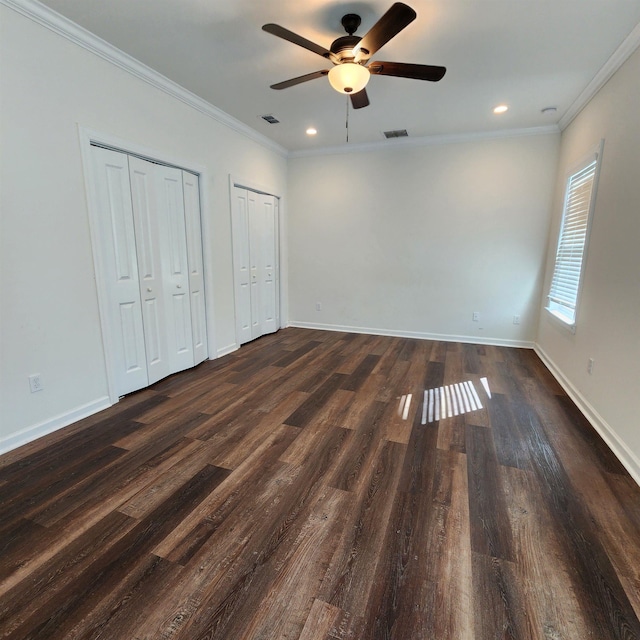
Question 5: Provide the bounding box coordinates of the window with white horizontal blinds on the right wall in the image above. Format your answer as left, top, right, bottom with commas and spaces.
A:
547, 143, 602, 330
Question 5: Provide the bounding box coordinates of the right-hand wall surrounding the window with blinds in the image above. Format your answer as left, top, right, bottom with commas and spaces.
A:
538, 50, 640, 482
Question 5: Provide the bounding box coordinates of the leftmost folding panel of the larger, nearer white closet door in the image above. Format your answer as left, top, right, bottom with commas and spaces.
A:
91, 147, 148, 395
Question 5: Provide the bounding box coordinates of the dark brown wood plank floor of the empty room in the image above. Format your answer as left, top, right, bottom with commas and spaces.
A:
0, 329, 640, 640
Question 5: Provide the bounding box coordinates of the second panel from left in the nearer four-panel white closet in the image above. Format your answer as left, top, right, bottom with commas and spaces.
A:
129, 157, 171, 384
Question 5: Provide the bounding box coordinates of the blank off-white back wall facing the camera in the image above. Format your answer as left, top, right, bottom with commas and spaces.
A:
288, 133, 559, 346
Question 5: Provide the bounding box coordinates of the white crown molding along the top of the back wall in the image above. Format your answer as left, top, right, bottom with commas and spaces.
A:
288, 124, 560, 158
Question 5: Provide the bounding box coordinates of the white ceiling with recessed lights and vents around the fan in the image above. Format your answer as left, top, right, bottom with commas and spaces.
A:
33, 0, 640, 151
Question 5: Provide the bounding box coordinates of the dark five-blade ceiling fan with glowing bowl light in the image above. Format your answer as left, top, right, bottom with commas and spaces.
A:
262, 2, 446, 109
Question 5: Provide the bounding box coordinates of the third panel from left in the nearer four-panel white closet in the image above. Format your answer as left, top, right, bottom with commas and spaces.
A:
155, 165, 194, 373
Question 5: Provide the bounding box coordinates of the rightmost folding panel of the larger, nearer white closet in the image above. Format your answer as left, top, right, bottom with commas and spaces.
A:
182, 171, 208, 364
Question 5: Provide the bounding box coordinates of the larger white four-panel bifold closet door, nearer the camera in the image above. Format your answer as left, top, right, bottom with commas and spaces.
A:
92, 147, 207, 395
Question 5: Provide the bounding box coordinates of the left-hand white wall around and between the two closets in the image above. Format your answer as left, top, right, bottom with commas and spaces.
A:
0, 5, 286, 450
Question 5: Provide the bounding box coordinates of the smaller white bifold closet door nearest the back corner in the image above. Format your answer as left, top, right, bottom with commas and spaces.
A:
231, 186, 279, 344
